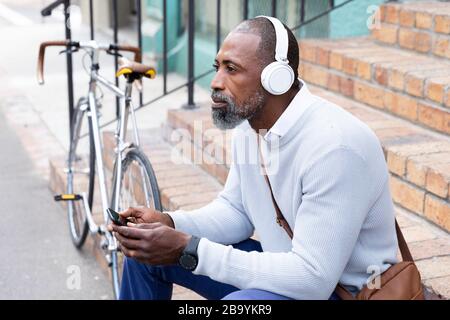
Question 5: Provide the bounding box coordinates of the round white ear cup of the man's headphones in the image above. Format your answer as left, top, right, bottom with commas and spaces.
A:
261, 61, 294, 96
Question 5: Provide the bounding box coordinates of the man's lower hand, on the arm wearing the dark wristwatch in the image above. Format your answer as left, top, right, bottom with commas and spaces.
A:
109, 223, 191, 265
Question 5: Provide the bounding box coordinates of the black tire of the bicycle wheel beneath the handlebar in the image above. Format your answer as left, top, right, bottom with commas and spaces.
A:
67, 98, 95, 249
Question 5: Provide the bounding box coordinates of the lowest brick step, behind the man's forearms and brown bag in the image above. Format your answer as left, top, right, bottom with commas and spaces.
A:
50, 127, 450, 299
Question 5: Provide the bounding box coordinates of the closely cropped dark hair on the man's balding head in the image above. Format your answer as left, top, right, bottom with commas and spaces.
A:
232, 17, 299, 87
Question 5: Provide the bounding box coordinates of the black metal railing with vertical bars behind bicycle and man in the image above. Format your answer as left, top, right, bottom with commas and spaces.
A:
41, 0, 374, 132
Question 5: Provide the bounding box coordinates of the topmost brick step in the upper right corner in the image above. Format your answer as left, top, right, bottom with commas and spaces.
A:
372, 1, 450, 59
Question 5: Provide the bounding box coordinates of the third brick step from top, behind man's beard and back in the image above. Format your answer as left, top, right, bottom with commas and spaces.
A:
164, 86, 450, 231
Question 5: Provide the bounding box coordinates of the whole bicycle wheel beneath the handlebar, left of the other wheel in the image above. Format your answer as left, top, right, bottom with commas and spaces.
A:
67, 99, 95, 248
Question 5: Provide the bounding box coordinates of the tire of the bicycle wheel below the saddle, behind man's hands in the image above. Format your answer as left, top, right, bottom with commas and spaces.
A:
111, 148, 162, 299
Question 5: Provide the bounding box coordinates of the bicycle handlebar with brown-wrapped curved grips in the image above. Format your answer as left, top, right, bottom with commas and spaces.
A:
37, 40, 142, 85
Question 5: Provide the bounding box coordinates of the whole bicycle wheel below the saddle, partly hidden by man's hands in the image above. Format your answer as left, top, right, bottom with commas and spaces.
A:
111, 148, 162, 298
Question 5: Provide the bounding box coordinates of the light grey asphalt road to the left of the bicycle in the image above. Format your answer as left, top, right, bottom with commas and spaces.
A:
0, 106, 112, 299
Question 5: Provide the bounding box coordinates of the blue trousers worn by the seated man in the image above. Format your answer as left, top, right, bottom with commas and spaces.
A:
119, 239, 339, 300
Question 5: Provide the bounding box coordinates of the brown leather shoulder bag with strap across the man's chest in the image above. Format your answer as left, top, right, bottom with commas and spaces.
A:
258, 139, 425, 300
